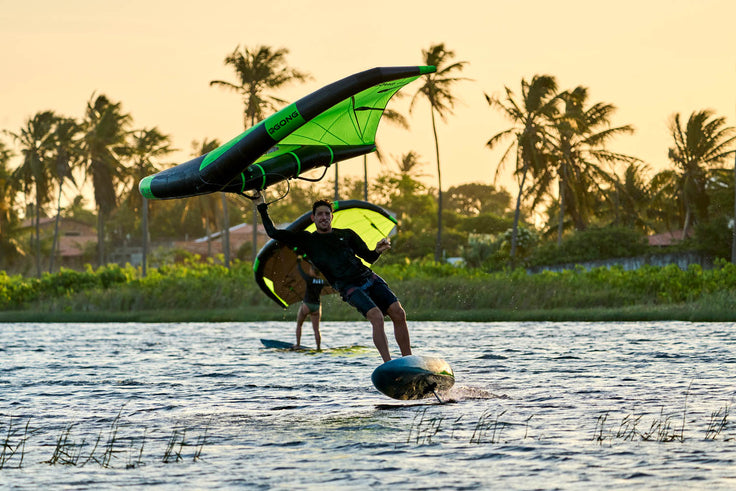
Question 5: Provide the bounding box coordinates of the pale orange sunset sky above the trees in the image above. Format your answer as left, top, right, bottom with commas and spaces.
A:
0, 0, 736, 198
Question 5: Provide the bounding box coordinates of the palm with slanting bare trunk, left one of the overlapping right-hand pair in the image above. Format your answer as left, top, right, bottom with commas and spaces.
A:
486, 75, 559, 264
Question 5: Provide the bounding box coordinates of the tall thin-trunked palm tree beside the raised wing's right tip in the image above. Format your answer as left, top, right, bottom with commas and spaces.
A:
409, 43, 468, 262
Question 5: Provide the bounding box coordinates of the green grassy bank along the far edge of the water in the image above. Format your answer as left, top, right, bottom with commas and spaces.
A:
0, 263, 736, 322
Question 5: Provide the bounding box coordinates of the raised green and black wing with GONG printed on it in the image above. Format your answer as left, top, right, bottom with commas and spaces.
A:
138, 66, 435, 199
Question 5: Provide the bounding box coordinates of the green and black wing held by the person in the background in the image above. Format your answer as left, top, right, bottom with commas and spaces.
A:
253, 200, 396, 308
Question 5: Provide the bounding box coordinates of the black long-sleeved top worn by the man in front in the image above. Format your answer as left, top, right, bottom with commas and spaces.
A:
258, 203, 381, 293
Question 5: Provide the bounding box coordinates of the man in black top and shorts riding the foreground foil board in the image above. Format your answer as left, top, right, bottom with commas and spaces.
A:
255, 194, 411, 362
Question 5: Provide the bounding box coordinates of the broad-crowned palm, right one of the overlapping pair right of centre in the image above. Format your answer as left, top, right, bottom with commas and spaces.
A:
548, 87, 637, 245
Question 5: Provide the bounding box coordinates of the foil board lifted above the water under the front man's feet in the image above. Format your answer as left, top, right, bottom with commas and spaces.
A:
371, 355, 455, 401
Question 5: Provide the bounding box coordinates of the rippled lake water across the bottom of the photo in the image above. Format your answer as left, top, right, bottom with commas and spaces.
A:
0, 322, 736, 490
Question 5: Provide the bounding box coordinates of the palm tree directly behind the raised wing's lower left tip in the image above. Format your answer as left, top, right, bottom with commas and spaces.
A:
121, 127, 174, 276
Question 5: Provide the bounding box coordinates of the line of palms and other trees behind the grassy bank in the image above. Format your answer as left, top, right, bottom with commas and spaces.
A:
0, 44, 736, 276
